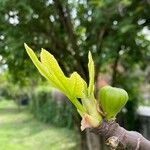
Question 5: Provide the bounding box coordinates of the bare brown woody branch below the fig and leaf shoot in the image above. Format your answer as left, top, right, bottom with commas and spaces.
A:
91, 121, 150, 150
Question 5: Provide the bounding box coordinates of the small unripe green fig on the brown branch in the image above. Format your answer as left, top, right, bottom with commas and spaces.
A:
98, 85, 128, 121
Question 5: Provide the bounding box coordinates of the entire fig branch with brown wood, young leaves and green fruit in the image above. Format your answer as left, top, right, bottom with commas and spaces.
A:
25, 44, 150, 150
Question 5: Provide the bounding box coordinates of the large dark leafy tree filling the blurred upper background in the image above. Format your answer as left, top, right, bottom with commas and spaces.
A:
0, 0, 150, 149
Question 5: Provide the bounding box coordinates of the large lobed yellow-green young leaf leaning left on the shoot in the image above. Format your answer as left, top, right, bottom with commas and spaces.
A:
24, 44, 87, 112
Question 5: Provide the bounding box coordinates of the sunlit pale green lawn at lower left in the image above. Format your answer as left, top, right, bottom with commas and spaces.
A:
0, 101, 78, 150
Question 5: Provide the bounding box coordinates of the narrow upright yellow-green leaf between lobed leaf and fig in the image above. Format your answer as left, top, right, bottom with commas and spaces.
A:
88, 51, 95, 97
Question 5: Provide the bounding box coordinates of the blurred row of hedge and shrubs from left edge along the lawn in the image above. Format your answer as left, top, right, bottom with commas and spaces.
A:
0, 74, 75, 128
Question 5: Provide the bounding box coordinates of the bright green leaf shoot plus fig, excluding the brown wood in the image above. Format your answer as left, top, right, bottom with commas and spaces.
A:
24, 44, 127, 130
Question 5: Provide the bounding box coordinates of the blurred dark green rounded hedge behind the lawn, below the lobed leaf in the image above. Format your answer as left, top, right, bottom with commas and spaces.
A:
29, 86, 75, 128
